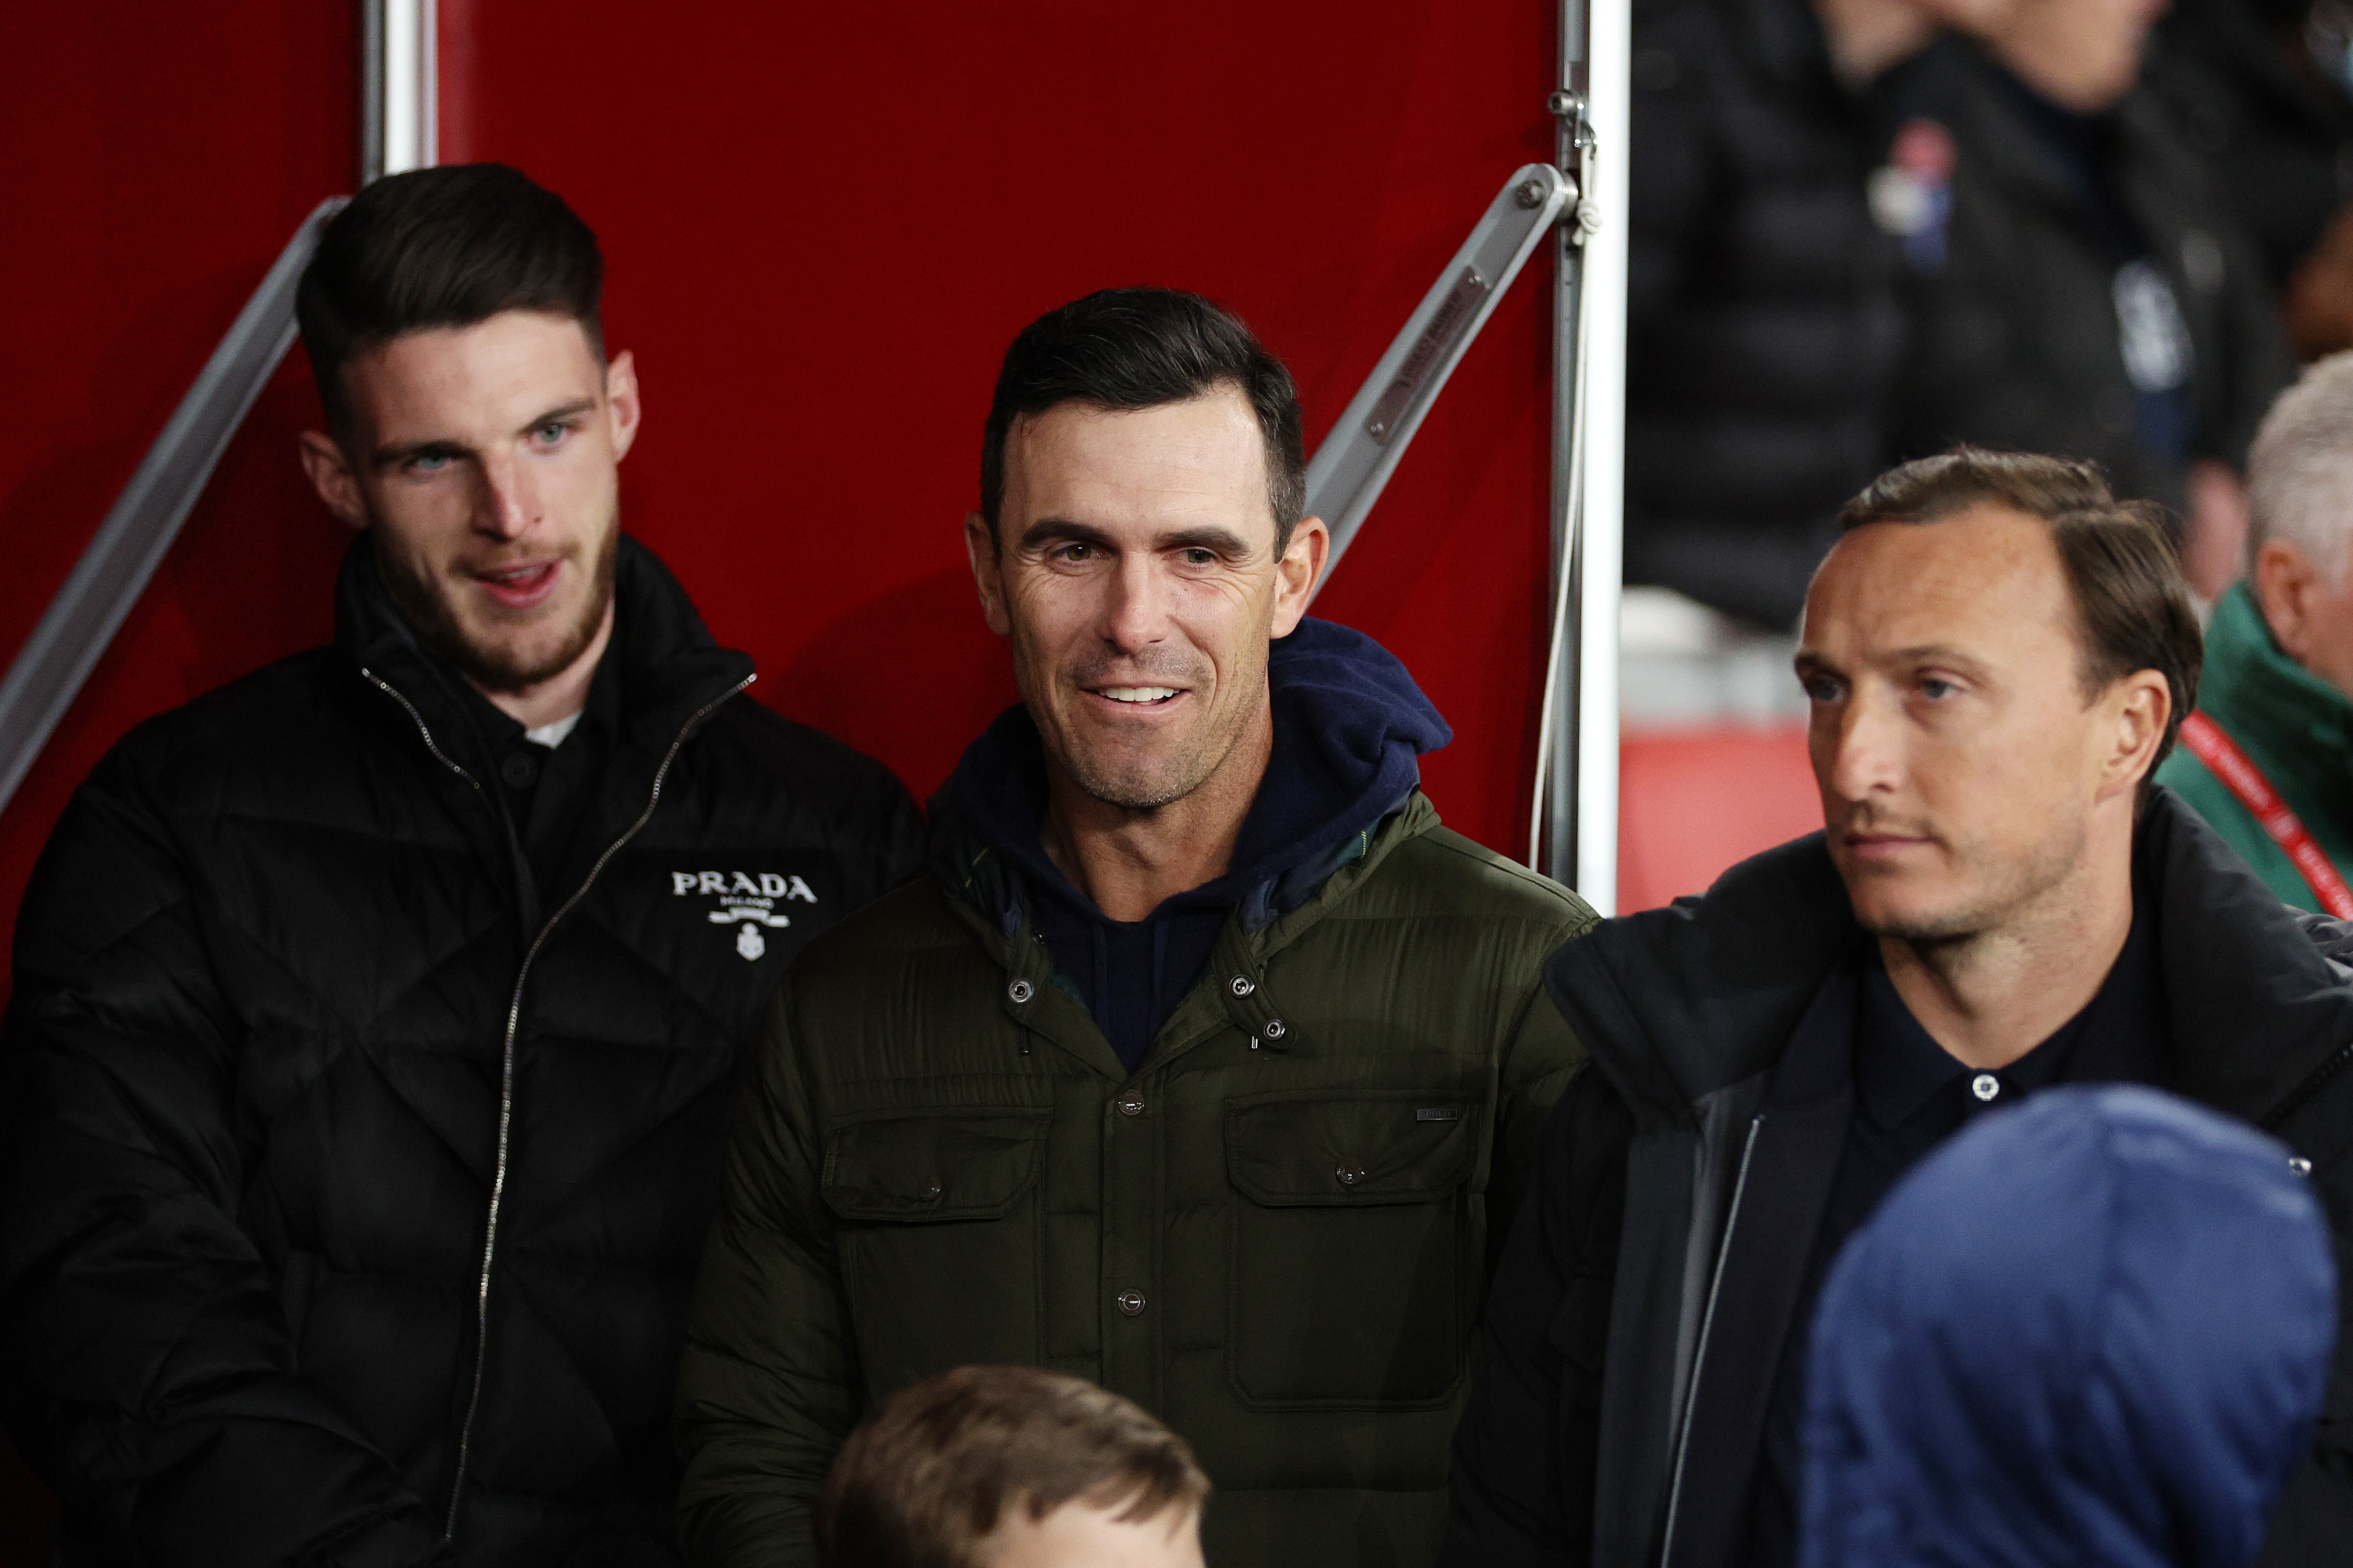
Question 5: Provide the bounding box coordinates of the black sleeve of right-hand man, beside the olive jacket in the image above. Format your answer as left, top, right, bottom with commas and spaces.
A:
1440, 1065, 1631, 1568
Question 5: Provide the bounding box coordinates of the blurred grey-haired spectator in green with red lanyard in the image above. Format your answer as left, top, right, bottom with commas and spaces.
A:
2157, 355, 2353, 919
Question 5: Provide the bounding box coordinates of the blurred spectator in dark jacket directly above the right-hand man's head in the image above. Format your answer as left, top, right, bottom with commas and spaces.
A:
1870, 0, 2292, 599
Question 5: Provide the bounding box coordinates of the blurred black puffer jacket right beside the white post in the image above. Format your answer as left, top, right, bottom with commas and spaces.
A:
1626, 0, 1901, 628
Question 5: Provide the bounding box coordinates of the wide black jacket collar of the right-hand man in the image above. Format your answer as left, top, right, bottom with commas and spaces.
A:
1546, 788, 2353, 1126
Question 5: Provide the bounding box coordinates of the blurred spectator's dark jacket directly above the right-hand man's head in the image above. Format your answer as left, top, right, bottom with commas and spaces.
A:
1887, 40, 2294, 510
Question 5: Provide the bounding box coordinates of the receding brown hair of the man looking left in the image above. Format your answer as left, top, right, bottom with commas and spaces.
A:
1838, 447, 2205, 794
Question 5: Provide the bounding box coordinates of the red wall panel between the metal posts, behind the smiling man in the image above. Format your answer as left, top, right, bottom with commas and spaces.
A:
442, 0, 1581, 849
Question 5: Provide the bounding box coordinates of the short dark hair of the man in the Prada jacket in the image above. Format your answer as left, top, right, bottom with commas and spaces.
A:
294, 162, 605, 425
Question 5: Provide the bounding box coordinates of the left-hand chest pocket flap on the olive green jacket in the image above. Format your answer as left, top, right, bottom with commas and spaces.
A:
823, 1110, 1052, 1223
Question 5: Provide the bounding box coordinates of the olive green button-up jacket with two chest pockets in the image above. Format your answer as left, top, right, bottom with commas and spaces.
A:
678, 794, 1596, 1568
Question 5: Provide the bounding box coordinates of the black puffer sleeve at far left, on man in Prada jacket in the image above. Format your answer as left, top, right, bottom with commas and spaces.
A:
0, 750, 440, 1568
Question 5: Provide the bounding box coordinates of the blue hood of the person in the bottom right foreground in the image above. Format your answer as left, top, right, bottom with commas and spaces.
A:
1800, 1088, 2336, 1568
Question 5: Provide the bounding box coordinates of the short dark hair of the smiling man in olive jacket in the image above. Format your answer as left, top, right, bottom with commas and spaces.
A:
981, 289, 1309, 555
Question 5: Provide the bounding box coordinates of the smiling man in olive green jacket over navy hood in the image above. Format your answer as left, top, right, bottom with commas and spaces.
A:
678, 289, 1593, 1568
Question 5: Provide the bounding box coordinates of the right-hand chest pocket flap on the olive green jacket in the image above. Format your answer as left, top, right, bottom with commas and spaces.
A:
1226, 1091, 1478, 1208
